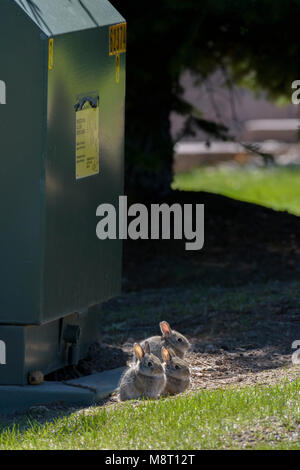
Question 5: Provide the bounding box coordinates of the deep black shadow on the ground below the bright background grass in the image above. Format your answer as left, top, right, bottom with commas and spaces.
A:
123, 191, 300, 292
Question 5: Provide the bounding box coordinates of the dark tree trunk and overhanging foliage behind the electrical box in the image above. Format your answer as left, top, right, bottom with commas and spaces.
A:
112, 0, 300, 195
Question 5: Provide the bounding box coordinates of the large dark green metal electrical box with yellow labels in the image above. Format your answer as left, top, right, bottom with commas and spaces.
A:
0, 0, 126, 384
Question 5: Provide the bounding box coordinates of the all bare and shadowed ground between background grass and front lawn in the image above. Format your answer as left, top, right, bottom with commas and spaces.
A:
50, 191, 300, 396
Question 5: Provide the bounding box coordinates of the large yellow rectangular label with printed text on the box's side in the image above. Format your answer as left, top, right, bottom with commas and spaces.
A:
76, 107, 99, 179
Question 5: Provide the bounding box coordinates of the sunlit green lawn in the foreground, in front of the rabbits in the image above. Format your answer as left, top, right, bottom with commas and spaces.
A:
0, 381, 300, 450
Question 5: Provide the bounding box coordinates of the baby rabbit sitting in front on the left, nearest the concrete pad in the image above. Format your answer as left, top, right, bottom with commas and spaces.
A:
119, 341, 166, 401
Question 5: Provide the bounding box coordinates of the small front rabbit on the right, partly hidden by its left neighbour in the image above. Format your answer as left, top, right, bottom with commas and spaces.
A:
162, 347, 190, 395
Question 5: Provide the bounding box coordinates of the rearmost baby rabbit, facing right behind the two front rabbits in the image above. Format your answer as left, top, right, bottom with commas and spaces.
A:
141, 321, 190, 360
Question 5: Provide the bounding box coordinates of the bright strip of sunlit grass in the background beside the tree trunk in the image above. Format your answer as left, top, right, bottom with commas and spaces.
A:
172, 166, 300, 215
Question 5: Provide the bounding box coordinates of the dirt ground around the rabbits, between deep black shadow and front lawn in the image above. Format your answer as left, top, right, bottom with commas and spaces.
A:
47, 283, 300, 398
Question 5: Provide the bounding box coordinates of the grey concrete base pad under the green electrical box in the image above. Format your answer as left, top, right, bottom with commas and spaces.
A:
0, 367, 125, 415
